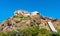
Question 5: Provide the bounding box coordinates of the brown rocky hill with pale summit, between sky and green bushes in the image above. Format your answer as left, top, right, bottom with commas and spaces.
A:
0, 10, 60, 32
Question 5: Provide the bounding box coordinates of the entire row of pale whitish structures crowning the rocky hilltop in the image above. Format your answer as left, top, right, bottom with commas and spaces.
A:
14, 10, 39, 16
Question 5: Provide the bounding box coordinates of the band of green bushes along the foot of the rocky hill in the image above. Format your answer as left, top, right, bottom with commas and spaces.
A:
0, 26, 60, 36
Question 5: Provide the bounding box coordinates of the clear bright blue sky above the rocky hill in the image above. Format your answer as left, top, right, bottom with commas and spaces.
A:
0, 0, 60, 22
